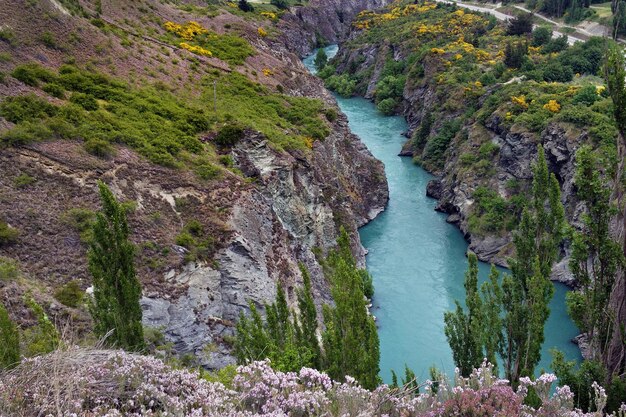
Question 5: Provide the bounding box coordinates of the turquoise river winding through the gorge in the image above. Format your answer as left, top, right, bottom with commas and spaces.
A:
304, 46, 580, 382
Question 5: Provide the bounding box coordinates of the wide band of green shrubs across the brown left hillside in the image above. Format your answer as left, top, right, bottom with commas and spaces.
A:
0, 64, 329, 166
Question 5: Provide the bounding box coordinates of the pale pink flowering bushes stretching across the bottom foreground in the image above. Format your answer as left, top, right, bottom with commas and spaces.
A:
0, 349, 626, 417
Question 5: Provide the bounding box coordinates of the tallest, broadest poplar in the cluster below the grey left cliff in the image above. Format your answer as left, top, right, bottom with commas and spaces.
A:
322, 228, 380, 389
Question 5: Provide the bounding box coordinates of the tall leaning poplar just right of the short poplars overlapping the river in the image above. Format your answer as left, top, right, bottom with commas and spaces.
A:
500, 146, 565, 383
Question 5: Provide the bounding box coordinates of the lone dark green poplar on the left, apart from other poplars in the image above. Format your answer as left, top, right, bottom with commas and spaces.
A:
87, 182, 144, 351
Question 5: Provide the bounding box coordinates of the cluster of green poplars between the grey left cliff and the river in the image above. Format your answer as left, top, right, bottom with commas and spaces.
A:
234, 229, 380, 389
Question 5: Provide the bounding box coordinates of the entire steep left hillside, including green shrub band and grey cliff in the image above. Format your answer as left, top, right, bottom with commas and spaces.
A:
0, 0, 388, 367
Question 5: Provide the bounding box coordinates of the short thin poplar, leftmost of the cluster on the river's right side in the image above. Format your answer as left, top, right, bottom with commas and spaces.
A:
444, 252, 484, 377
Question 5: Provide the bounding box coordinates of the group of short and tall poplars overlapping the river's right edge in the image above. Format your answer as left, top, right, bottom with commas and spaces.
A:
444, 147, 565, 385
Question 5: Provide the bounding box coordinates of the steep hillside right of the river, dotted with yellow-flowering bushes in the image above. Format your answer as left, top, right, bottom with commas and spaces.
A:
321, 1, 617, 281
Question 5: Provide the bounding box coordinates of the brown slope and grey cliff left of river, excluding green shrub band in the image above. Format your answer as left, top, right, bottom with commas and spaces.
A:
0, 0, 388, 368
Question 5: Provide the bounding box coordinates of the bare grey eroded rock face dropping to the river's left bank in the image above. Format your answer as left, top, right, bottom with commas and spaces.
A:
142, 116, 388, 368
